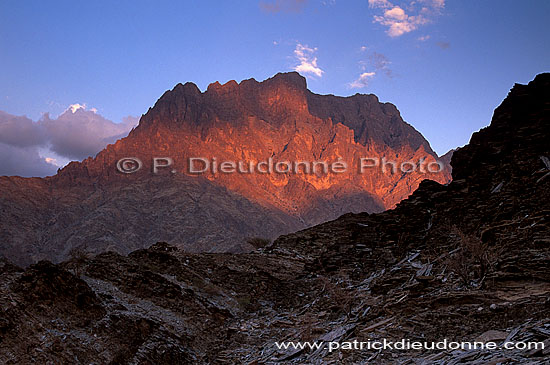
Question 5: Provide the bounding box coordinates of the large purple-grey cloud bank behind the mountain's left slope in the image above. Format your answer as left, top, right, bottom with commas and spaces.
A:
0, 104, 138, 176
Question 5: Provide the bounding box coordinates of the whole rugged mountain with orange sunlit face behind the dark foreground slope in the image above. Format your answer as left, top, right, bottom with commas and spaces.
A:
0, 72, 450, 263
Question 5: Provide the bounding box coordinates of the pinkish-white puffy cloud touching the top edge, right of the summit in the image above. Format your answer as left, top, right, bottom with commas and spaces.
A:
369, 0, 445, 38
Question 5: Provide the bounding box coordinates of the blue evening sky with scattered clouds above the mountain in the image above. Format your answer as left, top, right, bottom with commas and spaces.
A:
0, 0, 550, 175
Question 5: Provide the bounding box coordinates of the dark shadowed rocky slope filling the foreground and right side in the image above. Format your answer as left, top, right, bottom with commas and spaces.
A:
0, 74, 550, 364
